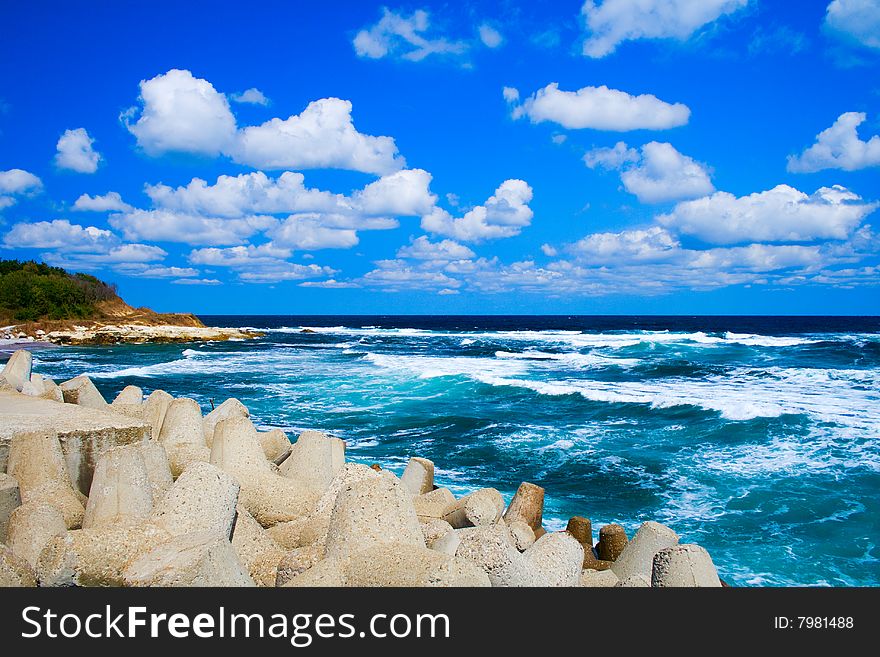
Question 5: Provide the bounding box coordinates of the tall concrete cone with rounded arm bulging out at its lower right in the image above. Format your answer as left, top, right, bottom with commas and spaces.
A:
211, 416, 319, 527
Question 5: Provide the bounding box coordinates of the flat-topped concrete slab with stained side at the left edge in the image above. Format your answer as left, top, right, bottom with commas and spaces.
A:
0, 392, 150, 493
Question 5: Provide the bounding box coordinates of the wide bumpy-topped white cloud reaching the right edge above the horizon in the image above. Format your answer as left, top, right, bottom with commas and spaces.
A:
657, 185, 878, 244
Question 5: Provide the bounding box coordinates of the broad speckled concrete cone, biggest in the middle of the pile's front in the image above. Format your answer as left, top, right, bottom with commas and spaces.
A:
325, 473, 425, 557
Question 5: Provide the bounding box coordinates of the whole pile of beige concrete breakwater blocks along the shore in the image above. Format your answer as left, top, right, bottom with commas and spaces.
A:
0, 346, 723, 587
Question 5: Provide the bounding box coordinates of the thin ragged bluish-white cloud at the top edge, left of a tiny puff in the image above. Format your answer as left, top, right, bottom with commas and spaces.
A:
353, 8, 468, 62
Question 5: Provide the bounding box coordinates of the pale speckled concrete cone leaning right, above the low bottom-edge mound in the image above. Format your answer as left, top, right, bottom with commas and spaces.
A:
150, 463, 239, 540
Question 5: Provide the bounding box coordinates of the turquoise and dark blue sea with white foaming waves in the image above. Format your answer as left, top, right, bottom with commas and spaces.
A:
24, 316, 880, 586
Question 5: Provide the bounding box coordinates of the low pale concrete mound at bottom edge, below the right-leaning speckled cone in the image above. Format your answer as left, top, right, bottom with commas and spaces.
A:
123, 532, 255, 587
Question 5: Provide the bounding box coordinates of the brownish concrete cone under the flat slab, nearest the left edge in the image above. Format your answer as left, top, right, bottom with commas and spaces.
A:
8, 433, 85, 529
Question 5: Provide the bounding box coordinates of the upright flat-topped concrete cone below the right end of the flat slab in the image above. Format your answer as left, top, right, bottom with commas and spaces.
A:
82, 446, 153, 529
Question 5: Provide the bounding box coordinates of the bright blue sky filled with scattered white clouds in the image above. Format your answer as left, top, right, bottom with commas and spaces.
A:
0, 0, 880, 314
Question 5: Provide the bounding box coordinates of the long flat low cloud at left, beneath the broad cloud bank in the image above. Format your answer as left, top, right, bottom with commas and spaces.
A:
108, 210, 277, 246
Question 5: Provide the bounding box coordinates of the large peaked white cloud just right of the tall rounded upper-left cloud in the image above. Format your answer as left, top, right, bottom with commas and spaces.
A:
231, 98, 405, 175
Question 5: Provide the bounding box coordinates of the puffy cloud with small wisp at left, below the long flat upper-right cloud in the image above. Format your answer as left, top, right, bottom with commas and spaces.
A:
584, 141, 715, 203
